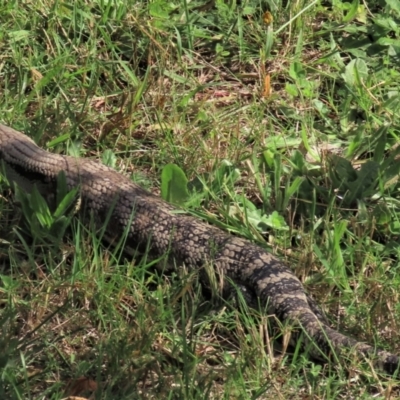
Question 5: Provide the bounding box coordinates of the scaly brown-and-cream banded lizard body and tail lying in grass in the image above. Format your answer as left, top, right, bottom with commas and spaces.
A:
0, 125, 400, 373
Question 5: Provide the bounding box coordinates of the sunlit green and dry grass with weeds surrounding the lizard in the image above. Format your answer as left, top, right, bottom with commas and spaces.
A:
0, 0, 400, 399
